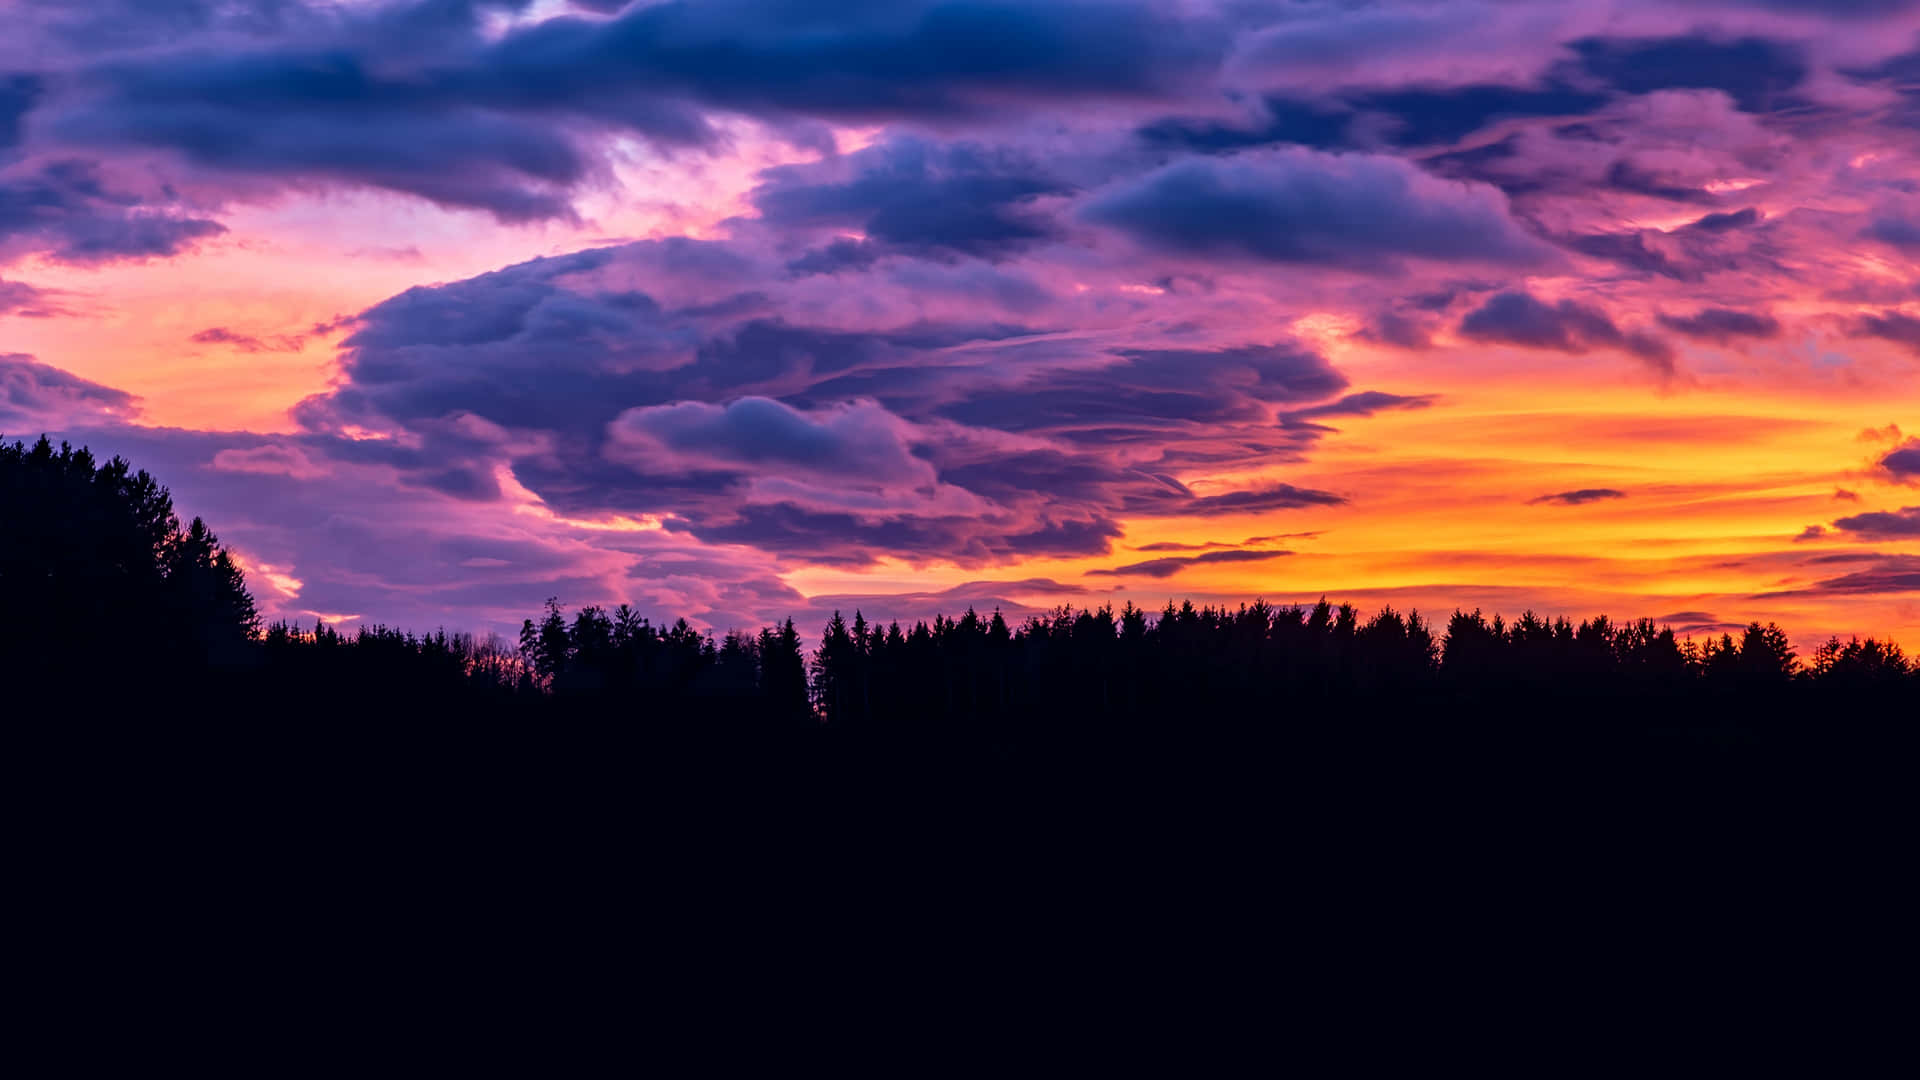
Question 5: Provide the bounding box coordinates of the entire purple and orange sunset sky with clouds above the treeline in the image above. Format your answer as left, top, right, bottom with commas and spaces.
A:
0, 0, 1920, 646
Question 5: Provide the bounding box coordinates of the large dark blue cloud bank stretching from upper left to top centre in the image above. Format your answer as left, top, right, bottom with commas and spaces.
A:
52, 0, 1225, 222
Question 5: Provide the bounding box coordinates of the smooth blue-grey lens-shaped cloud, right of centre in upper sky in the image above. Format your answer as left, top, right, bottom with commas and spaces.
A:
1083, 150, 1546, 271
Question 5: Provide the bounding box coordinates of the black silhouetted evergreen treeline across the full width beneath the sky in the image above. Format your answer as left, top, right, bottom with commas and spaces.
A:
0, 438, 1920, 718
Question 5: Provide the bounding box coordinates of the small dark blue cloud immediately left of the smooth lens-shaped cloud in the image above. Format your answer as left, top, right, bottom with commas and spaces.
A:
753, 138, 1071, 258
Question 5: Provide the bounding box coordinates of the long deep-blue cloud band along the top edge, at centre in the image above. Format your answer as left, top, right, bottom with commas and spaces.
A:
484, 0, 1225, 119
